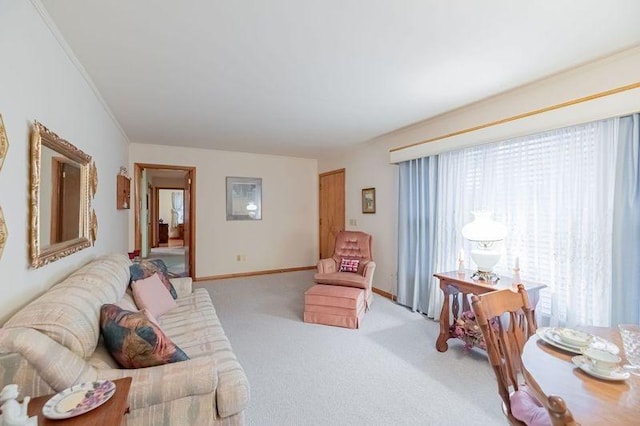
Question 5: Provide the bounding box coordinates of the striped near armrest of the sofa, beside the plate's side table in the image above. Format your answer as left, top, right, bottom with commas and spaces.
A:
97, 356, 218, 410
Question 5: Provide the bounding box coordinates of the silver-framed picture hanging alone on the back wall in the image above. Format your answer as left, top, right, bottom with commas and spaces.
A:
227, 177, 262, 220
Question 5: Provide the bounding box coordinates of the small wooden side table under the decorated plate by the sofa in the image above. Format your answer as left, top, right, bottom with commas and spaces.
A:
28, 377, 131, 426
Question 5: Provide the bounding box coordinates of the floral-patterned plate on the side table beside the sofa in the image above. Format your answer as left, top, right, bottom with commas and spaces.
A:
42, 380, 116, 419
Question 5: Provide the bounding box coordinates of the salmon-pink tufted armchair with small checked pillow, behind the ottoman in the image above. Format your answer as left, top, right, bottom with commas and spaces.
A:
313, 231, 376, 308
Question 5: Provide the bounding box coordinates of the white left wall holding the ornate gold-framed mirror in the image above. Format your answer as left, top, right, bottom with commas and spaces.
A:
0, 0, 128, 323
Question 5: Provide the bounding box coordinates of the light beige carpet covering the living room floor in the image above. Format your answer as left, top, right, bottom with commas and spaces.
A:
195, 271, 507, 425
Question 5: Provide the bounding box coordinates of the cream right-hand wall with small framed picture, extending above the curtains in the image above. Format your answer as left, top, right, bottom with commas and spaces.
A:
318, 48, 640, 293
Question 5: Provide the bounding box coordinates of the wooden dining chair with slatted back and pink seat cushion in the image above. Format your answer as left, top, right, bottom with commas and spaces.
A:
471, 284, 547, 425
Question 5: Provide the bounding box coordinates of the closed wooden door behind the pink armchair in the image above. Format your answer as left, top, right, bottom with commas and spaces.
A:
319, 169, 345, 259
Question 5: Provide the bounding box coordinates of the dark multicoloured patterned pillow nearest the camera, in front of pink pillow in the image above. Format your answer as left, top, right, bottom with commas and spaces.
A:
100, 304, 189, 368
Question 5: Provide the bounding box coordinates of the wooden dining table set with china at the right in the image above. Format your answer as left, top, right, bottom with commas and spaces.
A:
522, 327, 640, 426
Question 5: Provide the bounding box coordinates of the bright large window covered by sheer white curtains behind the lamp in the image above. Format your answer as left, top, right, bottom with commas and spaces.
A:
435, 119, 616, 325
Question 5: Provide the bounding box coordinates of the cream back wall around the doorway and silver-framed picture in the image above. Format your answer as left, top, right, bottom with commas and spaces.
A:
130, 143, 318, 278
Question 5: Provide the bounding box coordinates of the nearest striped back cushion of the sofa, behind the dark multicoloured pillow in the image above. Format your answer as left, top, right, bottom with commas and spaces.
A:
3, 254, 131, 359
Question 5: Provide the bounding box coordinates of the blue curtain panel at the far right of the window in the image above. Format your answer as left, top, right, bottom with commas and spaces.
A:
611, 114, 640, 325
